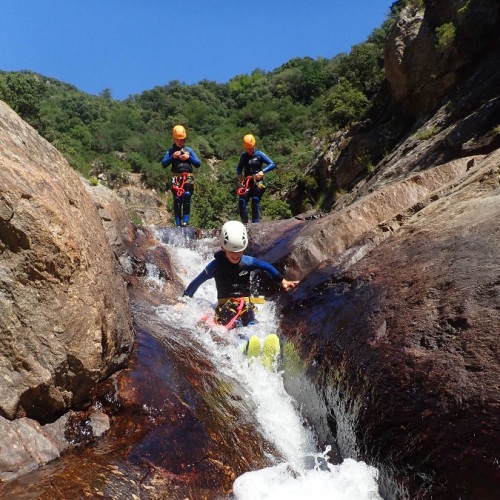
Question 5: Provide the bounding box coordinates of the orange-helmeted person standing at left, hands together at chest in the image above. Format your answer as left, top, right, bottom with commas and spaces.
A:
161, 125, 201, 227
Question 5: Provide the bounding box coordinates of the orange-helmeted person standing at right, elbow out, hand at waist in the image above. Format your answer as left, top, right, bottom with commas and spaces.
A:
236, 134, 276, 224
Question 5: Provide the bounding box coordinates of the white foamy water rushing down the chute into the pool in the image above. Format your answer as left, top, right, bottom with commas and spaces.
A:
157, 229, 381, 500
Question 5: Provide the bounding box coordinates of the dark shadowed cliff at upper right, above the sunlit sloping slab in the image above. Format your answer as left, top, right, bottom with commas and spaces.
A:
292, 0, 500, 208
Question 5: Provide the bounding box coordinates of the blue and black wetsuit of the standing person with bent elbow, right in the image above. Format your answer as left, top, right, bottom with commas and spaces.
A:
236, 150, 276, 224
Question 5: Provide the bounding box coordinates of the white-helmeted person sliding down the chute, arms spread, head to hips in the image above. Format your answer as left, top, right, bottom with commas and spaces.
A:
184, 221, 298, 327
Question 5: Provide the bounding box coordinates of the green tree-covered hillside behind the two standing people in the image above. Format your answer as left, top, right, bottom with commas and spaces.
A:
0, 11, 398, 228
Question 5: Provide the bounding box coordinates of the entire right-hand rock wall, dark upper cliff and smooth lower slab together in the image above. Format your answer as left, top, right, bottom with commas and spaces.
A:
251, 1, 500, 498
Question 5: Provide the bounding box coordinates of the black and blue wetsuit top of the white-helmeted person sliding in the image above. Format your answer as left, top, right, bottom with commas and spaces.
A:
184, 250, 283, 299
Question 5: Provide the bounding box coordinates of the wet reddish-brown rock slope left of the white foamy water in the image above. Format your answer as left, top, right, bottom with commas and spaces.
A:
0, 233, 276, 499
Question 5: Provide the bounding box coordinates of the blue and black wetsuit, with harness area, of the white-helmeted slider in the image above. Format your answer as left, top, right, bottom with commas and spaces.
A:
184, 250, 283, 326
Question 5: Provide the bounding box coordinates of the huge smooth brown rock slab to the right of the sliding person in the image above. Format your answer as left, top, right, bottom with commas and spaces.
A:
266, 150, 500, 498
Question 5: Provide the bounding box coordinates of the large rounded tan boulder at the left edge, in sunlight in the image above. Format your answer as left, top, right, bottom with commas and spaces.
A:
0, 102, 133, 421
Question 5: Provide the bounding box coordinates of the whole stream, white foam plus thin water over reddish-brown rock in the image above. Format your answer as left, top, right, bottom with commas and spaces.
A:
0, 229, 381, 500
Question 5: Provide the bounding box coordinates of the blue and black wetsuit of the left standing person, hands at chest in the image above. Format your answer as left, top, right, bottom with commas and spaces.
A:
161, 144, 201, 226
